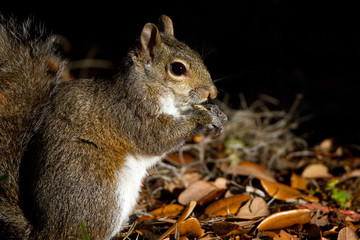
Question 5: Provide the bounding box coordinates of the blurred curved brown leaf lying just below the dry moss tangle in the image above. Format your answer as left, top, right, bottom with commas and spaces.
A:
227, 161, 276, 182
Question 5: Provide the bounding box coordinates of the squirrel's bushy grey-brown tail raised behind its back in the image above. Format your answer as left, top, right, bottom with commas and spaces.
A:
0, 16, 64, 239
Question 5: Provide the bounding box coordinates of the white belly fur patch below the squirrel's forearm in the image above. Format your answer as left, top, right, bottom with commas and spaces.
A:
109, 156, 162, 239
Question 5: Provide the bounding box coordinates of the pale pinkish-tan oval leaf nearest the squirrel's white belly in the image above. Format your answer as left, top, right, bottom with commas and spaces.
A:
178, 180, 216, 205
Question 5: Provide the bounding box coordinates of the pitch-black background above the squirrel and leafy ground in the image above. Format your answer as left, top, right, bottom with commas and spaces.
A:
0, 0, 360, 144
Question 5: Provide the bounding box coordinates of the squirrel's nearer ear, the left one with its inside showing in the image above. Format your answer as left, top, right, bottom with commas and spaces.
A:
140, 23, 161, 62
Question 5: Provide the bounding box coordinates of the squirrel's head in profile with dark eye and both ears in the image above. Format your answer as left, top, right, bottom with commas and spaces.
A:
134, 15, 217, 109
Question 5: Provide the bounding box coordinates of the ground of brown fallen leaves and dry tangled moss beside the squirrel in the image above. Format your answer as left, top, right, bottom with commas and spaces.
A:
118, 95, 360, 240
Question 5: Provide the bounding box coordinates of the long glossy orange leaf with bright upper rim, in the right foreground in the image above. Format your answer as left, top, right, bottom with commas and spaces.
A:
257, 209, 311, 231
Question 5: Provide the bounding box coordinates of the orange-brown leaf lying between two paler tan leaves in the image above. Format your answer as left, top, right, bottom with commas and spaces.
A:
205, 194, 251, 216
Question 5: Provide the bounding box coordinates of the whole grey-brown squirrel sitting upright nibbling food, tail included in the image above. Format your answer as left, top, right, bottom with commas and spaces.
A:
0, 15, 227, 239
